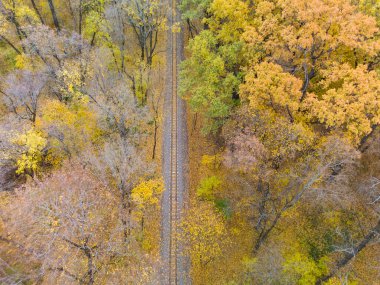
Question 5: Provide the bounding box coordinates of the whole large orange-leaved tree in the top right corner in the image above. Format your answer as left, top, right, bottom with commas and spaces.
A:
241, 0, 380, 145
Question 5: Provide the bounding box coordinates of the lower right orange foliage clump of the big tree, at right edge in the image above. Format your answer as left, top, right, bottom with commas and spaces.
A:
307, 64, 380, 145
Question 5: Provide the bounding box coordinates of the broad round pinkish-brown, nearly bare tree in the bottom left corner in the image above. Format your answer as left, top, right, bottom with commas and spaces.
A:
0, 164, 130, 284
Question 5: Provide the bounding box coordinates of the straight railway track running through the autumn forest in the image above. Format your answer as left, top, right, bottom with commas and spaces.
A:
169, 0, 178, 285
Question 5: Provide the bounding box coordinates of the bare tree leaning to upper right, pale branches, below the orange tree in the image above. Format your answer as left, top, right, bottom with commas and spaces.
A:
252, 138, 358, 254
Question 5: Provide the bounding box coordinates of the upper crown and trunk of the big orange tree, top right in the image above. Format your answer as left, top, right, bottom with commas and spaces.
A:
244, 0, 380, 101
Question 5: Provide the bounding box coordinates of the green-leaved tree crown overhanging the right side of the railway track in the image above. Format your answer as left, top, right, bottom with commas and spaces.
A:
180, 31, 240, 133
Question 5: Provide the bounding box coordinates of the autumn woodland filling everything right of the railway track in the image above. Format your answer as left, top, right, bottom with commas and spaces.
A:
181, 0, 380, 284
